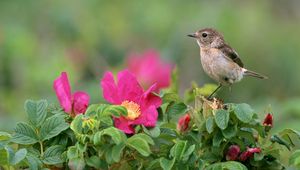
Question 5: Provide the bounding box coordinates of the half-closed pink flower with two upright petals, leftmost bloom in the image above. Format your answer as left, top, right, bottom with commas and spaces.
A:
53, 72, 90, 117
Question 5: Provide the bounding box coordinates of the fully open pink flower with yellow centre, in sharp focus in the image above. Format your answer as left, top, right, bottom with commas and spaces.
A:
101, 70, 162, 134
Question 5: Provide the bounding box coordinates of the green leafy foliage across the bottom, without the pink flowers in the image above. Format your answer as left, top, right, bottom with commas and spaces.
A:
0, 82, 300, 170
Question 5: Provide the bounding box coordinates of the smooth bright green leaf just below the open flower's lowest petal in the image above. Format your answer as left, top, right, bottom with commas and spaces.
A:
126, 137, 151, 157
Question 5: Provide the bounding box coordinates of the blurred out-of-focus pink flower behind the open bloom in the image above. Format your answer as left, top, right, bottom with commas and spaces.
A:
127, 50, 172, 92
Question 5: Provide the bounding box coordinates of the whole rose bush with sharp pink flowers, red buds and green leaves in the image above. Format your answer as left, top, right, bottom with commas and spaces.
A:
0, 52, 300, 170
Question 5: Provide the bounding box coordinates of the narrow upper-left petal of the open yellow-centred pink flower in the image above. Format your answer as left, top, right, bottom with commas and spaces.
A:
101, 72, 121, 104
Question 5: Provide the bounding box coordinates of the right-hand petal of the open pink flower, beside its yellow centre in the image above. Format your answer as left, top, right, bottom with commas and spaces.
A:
132, 105, 158, 127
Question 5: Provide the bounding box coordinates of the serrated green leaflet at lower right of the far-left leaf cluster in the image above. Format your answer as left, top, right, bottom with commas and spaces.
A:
42, 145, 64, 165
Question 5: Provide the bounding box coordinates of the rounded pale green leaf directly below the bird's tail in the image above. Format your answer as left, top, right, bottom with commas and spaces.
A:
234, 103, 254, 123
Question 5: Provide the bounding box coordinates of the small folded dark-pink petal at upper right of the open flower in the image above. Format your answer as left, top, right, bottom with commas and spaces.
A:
139, 84, 162, 108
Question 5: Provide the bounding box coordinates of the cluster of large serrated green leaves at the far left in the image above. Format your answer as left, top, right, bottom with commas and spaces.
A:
0, 100, 71, 169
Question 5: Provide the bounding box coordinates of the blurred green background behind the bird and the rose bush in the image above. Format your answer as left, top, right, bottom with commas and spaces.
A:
0, 0, 300, 133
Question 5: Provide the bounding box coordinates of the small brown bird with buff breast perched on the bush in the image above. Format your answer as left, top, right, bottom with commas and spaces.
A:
188, 28, 268, 99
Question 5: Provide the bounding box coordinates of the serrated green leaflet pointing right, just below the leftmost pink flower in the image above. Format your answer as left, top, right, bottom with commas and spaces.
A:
41, 115, 69, 141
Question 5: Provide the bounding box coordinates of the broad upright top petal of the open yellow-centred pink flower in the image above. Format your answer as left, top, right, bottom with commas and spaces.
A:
118, 70, 144, 103
